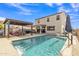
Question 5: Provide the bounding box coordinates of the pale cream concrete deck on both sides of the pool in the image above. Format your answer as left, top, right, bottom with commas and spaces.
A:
0, 34, 79, 56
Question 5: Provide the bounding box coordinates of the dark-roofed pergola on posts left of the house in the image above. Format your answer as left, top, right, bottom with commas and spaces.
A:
4, 18, 33, 37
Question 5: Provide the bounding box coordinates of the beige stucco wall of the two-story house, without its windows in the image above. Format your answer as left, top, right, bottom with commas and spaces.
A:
35, 12, 66, 33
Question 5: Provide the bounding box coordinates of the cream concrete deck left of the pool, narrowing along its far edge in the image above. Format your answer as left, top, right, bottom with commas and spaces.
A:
0, 34, 45, 56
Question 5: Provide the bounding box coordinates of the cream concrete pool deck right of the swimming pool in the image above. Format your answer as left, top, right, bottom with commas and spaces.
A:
61, 36, 79, 56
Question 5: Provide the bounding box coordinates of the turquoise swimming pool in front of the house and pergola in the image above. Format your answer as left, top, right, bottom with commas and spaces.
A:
12, 35, 67, 56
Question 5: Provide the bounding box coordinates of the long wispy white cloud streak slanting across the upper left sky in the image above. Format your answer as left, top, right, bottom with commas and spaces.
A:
7, 3, 33, 15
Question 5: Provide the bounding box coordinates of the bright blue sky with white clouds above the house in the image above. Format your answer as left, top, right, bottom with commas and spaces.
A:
0, 3, 79, 29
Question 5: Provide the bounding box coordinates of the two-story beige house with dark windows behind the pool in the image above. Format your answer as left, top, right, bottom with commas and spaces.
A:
35, 12, 72, 34
